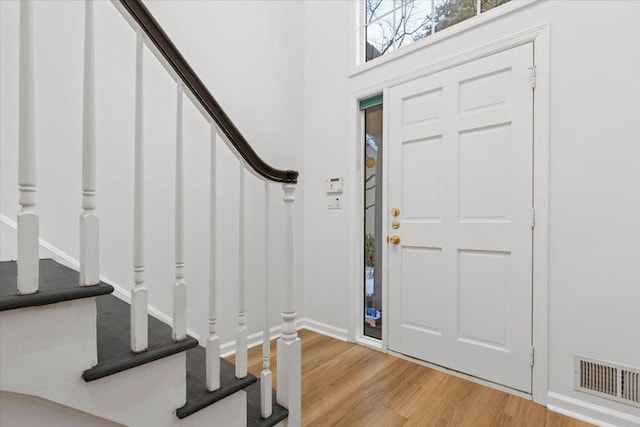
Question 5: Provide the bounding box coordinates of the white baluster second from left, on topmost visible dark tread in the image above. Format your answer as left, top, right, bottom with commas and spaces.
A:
80, 0, 100, 286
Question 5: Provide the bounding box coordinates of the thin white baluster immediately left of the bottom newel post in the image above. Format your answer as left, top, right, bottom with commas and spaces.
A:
260, 181, 273, 418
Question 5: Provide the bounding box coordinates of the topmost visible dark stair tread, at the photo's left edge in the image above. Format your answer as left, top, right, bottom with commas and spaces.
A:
0, 259, 113, 311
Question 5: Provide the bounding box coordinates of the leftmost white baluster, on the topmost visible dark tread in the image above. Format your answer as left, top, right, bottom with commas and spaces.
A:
18, 0, 40, 294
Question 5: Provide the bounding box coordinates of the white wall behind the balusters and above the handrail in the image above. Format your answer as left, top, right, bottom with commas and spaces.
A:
0, 1, 303, 352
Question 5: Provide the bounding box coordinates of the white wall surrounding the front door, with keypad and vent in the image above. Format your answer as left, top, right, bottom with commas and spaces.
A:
304, 1, 640, 421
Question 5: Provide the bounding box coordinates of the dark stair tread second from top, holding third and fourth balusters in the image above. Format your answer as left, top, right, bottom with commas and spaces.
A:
82, 295, 198, 381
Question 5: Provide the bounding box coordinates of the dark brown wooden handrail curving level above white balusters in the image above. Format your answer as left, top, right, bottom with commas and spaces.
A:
120, 0, 298, 184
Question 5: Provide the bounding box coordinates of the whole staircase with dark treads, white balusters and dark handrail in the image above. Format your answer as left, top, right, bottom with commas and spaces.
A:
0, 0, 301, 427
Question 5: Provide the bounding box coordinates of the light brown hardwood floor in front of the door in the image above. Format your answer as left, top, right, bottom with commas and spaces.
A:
231, 330, 590, 427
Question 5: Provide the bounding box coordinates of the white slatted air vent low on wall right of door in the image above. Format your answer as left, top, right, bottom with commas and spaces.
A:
574, 356, 640, 408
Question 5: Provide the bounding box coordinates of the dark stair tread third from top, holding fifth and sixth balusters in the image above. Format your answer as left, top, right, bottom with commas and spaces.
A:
176, 346, 256, 418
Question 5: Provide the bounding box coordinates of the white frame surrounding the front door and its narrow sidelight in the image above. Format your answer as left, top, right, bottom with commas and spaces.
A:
348, 23, 550, 405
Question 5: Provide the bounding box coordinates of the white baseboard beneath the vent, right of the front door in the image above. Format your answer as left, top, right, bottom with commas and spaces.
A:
547, 391, 640, 427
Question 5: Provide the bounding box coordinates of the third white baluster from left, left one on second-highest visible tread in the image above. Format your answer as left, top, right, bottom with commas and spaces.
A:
131, 30, 148, 353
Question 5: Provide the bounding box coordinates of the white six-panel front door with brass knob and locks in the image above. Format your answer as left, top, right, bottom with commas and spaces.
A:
388, 44, 533, 393
